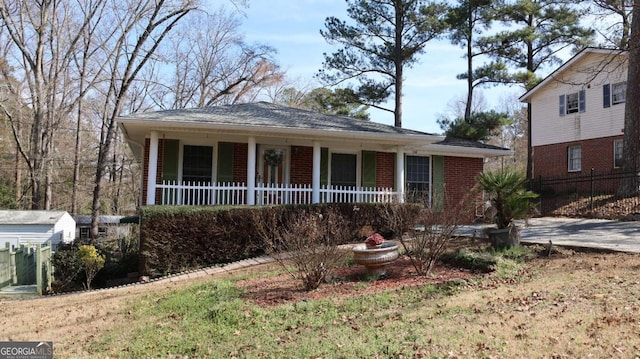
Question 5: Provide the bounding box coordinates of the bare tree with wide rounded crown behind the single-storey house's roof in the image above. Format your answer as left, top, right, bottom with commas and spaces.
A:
153, 8, 283, 108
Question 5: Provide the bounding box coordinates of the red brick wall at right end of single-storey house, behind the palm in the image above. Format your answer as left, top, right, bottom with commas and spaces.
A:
444, 156, 484, 223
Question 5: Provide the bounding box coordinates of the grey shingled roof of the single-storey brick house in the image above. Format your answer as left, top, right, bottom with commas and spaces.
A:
118, 102, 510, 157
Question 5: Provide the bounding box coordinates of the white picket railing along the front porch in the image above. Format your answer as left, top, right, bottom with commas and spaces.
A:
156, 181, 398, 205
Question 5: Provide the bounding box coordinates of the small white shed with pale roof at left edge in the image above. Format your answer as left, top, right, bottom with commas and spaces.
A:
0, 210, 76, 251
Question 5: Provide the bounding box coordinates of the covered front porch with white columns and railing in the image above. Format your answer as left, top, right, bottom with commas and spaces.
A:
143, 131, 408, 205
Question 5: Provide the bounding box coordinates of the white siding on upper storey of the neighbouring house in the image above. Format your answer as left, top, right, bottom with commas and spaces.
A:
531, 53, 627, 146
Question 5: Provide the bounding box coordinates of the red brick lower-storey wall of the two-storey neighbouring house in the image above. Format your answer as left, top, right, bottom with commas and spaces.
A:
533, 135, 622, 178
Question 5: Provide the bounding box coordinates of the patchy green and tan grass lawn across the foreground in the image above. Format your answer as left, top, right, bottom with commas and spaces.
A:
69, 245, 640, 358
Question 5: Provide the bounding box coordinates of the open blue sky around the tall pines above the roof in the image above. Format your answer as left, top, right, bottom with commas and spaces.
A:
241, 0, 523, 134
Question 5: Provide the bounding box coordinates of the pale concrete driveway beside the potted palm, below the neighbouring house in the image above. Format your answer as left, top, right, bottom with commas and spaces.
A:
461, 217, 640, 253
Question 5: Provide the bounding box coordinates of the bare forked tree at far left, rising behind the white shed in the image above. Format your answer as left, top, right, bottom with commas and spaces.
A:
0, 0, 106, 209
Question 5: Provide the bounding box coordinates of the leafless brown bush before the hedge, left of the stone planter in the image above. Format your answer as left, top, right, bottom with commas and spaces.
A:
256, 209, 350, 290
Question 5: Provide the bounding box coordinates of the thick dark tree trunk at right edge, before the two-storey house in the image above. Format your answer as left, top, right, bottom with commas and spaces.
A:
618, 2, 640, 197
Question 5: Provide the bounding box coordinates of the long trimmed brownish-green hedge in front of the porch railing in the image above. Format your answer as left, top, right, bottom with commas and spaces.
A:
139, 203, 422, 276
